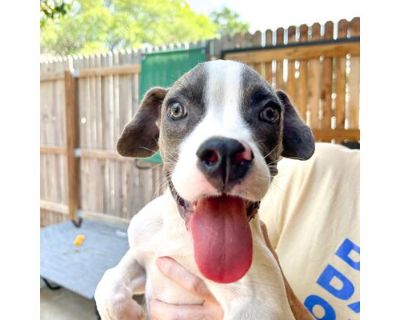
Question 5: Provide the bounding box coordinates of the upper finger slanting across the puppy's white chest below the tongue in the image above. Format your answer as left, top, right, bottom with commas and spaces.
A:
156, 257, 214, 300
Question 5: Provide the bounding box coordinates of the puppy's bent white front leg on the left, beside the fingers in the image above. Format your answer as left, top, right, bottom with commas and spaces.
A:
95, 250, 146, 320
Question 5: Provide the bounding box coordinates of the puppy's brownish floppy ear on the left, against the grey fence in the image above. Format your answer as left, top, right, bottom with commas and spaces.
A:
117, 87, 168, 158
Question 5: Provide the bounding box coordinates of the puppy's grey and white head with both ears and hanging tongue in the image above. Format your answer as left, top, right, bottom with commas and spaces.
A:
117, 60, 314, 282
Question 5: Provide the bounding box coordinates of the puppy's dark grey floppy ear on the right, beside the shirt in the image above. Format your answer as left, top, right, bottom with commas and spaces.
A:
276, 90, 315, 160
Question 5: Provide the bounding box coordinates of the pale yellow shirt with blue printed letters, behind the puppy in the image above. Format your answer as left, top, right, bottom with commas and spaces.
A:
260, 143, 360, 320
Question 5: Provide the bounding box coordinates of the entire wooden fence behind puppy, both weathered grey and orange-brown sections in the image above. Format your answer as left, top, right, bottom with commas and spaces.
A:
40, 18, 360, 226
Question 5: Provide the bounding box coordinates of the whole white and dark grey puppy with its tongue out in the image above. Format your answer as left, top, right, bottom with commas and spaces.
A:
95, 60, 314, 320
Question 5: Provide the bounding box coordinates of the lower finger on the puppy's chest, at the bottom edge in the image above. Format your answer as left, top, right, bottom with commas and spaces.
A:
150, 299, 207, 320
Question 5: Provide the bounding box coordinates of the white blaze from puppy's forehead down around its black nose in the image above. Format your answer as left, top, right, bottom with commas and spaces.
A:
172, 60, 270, 201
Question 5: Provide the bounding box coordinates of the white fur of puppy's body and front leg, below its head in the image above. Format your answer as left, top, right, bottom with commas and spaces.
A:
95, 192, 294, 320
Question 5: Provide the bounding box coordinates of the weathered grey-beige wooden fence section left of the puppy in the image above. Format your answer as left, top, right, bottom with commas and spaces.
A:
41, 53, 161, 225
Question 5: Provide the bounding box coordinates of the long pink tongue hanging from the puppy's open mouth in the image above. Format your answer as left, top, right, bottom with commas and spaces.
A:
190, 196, 253, 283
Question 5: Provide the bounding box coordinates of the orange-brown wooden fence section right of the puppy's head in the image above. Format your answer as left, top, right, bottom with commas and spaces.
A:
223, 18, 360, 142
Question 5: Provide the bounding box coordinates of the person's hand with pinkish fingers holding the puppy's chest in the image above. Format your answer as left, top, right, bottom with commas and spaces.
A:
150, 257, 224, 320
